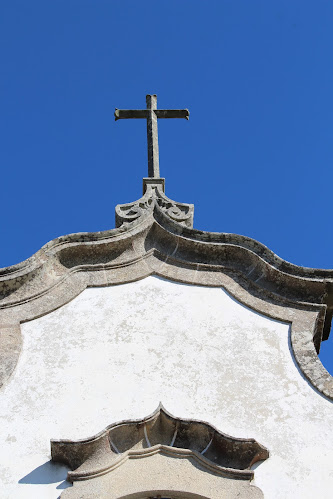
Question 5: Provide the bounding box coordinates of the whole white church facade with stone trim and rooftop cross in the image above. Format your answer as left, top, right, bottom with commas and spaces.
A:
0, 96, 333, 499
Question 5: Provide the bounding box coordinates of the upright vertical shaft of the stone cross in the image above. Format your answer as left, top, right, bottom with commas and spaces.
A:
146, 95, 160, 178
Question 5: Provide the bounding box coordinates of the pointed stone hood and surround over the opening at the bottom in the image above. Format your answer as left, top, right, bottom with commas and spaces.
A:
51, 404, 269, 499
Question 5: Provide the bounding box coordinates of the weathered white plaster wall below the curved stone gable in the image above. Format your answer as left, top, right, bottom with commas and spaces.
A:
0, 277, 333, 499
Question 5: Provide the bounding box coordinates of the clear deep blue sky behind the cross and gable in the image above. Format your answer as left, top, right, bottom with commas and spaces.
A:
0, 0, 333, 373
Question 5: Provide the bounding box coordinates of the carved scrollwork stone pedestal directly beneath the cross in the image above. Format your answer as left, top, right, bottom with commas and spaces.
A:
116, 179, 194, 228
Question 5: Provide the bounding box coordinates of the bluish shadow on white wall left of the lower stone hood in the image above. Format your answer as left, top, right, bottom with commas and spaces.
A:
18, 461, 72, 489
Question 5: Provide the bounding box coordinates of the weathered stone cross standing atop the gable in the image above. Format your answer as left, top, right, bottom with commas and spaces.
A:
114, 94, 190, 178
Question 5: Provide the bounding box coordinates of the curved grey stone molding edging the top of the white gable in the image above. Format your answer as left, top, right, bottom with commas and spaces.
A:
0, 209, 333, 399
